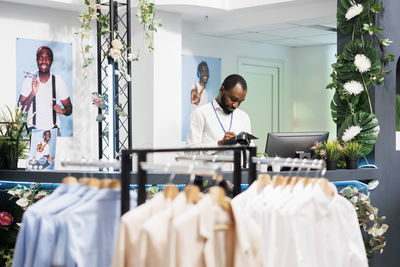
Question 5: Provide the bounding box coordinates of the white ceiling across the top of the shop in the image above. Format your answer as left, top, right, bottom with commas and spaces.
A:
0, 0, 337, 47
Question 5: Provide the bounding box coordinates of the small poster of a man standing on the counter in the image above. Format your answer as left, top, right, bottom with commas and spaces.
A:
28, 129, 57, 170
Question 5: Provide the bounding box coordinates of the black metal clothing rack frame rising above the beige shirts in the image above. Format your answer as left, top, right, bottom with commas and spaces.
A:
121, 146, 257, 215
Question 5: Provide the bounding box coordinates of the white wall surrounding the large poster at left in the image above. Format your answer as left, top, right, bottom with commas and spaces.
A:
0, 2, 97, 168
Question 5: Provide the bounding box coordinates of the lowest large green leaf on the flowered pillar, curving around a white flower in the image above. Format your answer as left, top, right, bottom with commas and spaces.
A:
338, 111, 380, 157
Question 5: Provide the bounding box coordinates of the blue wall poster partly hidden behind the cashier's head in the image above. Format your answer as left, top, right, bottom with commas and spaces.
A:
182, 55, 221, 141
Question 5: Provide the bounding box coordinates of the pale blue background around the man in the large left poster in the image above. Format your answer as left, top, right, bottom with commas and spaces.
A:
16, 38, 74, 136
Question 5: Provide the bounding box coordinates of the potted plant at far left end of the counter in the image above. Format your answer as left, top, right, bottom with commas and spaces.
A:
0, 106, 29, 169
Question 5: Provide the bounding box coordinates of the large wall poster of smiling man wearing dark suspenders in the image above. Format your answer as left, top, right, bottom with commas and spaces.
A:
16, 38, 73, 136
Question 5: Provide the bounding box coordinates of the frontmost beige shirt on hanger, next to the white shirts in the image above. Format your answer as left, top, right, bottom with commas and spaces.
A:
168, 196, 264, 267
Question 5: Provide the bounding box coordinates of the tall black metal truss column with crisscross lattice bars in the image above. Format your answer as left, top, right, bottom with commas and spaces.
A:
97, 0, 132, 159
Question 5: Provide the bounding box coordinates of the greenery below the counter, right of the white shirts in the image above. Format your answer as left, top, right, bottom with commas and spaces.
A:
340, 186, 389, 258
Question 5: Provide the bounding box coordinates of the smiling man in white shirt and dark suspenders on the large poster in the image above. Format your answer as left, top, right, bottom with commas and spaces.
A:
19, 46, 72, 130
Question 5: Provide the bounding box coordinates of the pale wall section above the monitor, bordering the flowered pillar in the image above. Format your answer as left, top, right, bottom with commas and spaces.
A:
293, 45, 336, 139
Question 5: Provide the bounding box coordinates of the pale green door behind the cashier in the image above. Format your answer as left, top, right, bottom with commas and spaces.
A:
239, 59, 281, 152
